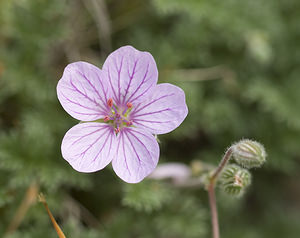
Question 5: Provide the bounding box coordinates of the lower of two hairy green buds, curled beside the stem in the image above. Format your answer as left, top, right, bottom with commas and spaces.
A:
220, 164, 251, 196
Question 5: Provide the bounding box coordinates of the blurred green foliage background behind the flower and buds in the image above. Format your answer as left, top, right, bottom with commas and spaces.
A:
0, 0, 300, 238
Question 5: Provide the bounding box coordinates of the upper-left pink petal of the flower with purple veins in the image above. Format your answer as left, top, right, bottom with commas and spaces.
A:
57, 62, 108, 121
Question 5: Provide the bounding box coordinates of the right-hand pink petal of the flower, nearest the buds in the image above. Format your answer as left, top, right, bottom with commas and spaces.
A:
130, 83, 188, 134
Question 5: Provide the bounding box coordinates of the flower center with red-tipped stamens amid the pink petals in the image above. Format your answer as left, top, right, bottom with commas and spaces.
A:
103, 98, 132, 134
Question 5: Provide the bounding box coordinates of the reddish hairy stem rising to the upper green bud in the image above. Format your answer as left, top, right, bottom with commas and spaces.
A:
207, 147, 232, 238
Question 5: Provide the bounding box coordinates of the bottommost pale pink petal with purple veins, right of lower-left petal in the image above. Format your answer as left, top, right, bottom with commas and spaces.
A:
112, 127, 159, 183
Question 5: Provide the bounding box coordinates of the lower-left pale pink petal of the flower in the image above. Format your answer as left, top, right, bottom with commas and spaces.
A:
61, 122, 116, 172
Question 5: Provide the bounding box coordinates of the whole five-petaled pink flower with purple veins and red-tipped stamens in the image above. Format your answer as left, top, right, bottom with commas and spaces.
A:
57, 46, 188, 183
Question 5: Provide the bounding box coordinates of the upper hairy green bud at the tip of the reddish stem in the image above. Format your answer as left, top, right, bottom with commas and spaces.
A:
232, 140, 267, 169
